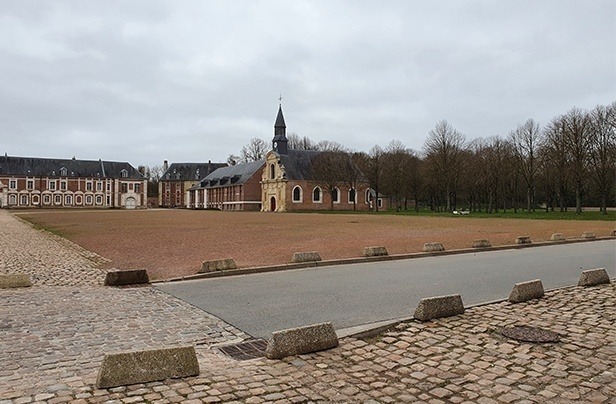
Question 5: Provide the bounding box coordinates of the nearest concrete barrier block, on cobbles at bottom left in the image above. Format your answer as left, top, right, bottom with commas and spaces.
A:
96, 346, 199, 389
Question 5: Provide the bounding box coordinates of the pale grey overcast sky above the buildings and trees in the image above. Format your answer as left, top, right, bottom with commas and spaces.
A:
0, 0, 616, 167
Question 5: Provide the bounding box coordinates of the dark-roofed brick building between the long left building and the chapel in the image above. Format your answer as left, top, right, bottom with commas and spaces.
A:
158, 160, 227, 208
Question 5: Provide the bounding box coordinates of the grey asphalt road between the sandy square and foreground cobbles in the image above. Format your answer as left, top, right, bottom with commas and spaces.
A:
156, 240, 616, 338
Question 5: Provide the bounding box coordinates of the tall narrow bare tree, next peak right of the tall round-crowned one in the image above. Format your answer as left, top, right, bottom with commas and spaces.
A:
509, 118, 543, 213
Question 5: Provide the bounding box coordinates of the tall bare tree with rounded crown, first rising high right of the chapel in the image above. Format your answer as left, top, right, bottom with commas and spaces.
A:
424, 120, 466, 211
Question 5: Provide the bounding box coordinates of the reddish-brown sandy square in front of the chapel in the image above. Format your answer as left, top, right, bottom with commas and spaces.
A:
16, 209, 614, 279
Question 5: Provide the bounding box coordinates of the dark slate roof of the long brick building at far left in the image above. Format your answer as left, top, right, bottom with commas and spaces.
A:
0, 155, 144, 179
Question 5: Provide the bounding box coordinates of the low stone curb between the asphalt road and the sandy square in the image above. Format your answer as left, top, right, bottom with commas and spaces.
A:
150, 236, 616, 284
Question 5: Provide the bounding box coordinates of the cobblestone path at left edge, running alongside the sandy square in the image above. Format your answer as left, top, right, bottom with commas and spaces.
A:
0, 209, 108, 286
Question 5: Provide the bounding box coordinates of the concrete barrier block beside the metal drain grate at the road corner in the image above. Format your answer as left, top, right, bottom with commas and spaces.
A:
265, 323, 338, 359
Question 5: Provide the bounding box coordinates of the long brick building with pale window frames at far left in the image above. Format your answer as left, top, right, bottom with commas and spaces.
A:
0, 155, 147, 209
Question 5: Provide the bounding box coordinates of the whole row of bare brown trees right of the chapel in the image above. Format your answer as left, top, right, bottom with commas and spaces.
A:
378, 102, 616, 213
